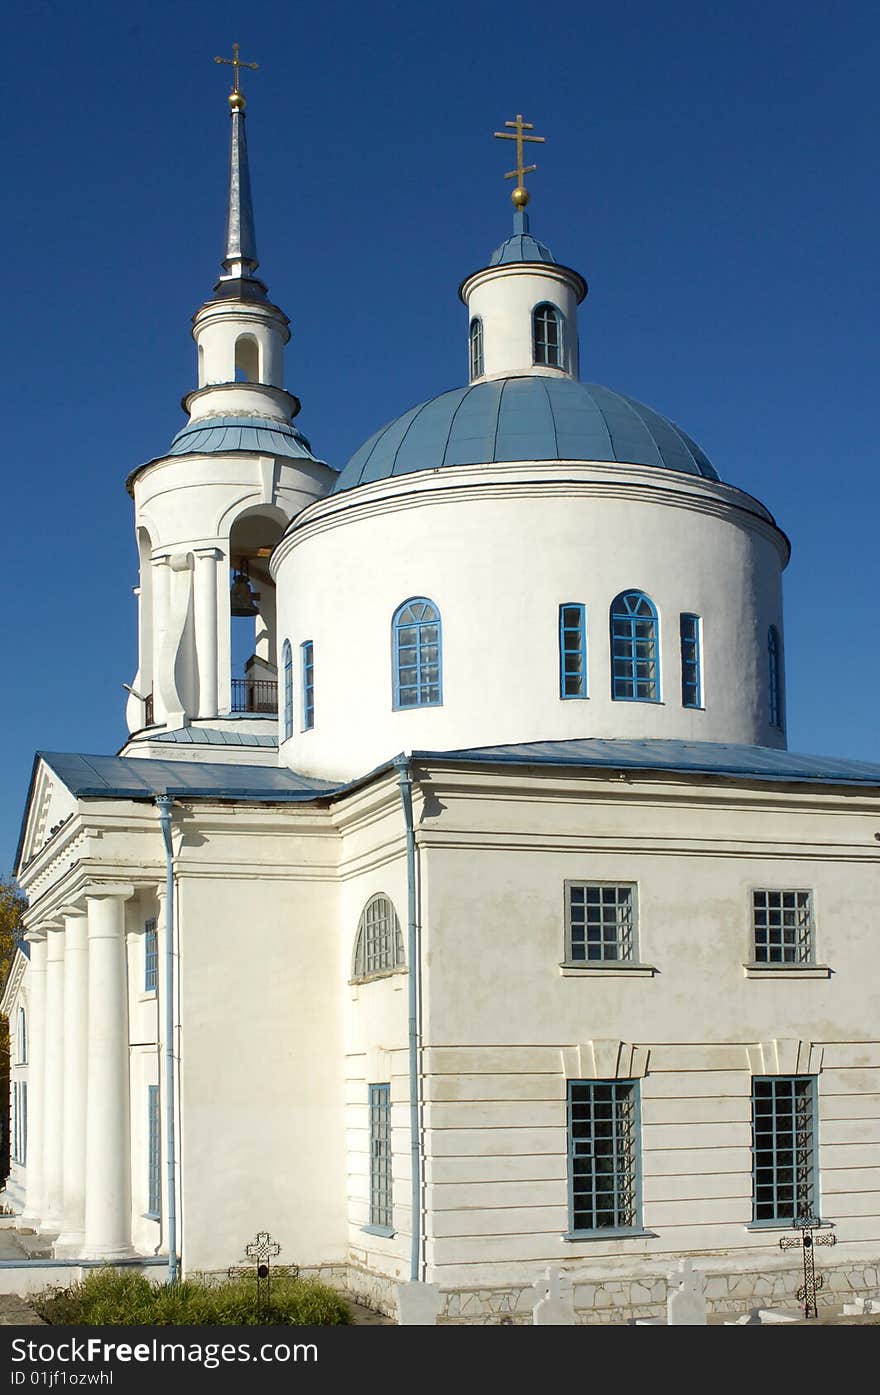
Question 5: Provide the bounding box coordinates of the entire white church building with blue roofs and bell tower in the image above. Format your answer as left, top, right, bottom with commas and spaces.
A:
1, 81, 880, 1322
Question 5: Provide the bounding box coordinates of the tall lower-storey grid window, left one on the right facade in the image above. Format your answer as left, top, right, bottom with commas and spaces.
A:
568, 1080, 642, 1235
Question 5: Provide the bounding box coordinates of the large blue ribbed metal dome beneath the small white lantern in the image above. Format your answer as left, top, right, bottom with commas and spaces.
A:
333, 375, 718, 492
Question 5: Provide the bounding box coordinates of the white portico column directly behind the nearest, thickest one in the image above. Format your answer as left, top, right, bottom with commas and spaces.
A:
54, 911, 89, 1258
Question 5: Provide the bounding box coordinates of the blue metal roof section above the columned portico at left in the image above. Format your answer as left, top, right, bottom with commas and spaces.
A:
38, 751, 339, 804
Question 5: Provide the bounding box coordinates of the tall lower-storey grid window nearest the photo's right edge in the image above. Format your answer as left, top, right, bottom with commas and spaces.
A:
752, 1076, 819, 1225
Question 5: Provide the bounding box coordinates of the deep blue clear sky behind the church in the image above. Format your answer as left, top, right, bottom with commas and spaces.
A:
0, 0, 880, 870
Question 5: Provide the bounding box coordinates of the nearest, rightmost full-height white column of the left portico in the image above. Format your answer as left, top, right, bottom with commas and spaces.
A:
82, 887, 134, 1258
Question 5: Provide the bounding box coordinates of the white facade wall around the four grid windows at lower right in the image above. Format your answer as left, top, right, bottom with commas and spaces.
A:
418, 770, 880, 1288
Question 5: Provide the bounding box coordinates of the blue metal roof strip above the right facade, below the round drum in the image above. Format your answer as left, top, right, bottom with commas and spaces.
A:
413, 737, 880, 787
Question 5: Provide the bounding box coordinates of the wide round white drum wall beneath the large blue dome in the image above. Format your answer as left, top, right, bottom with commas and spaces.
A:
272, 462, 787, 778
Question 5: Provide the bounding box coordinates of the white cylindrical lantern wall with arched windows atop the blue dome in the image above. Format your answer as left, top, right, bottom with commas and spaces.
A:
462, 262, 580, 382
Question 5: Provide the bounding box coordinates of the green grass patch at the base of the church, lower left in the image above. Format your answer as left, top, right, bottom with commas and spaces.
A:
29, 1268, 350, 1327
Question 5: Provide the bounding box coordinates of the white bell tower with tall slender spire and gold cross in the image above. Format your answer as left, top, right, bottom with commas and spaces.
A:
126, 45, 336, 762
